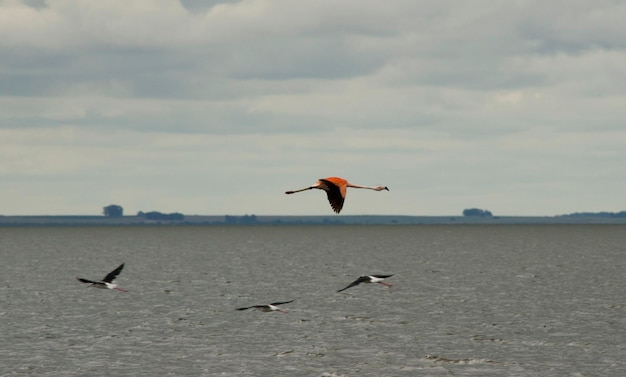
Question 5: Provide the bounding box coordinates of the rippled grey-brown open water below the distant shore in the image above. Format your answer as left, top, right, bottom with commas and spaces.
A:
0, 225, 626, 377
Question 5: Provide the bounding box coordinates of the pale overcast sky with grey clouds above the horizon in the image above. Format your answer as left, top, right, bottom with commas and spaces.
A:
0, 0, 626, 216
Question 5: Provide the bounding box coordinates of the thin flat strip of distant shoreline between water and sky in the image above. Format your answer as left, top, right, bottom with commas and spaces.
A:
0, 215, 626, 227
